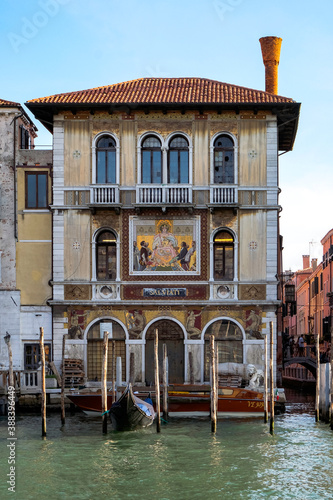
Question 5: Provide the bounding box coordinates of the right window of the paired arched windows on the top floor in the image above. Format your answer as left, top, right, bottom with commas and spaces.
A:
168, 135, 189, 184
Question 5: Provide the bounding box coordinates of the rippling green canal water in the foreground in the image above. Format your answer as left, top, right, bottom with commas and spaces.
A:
0, 391, 333, 500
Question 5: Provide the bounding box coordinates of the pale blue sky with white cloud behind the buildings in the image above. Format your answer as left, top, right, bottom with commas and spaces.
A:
0, 0, 333, 271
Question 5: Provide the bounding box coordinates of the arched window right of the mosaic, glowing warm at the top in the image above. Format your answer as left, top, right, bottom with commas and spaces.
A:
214, 230, 234, 281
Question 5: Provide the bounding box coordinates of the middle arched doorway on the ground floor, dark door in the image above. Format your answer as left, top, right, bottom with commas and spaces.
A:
145, 319, 184, 385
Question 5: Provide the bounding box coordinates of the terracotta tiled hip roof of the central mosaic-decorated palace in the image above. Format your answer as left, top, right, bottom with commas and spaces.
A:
28, 78, 294, 105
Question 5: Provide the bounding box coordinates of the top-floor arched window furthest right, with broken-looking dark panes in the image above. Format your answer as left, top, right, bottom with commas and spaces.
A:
214, 135, 234, 184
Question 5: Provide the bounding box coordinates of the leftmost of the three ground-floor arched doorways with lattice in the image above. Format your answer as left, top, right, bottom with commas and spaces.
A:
87, 319, 126, 381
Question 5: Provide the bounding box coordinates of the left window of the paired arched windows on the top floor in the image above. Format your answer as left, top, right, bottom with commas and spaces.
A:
141, 135, 162, 184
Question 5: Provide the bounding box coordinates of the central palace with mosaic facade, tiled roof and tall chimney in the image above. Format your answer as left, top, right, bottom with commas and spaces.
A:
22, 37, 300, 384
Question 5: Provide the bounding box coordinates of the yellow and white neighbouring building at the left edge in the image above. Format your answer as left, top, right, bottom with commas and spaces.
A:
0, 99, 52, 383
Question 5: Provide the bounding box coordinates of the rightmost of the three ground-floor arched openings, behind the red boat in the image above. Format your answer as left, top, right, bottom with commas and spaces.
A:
204, 319, 243, 381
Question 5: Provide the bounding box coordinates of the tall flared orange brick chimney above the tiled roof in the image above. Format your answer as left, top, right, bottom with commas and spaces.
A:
259, 36, 282, 94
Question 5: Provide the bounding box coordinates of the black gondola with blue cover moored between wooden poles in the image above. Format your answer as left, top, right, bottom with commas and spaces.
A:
110, 384, 155, 431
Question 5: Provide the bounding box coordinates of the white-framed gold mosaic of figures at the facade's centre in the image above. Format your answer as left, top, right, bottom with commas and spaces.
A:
129, 217, 200, 275
